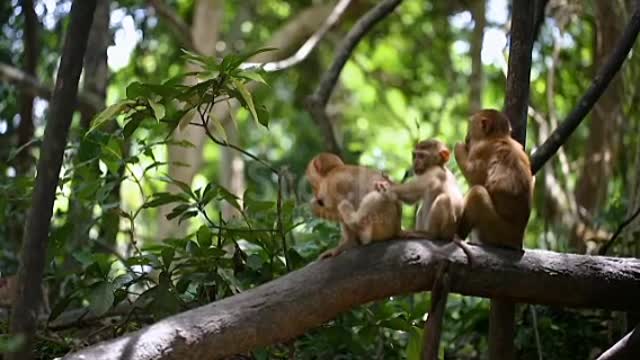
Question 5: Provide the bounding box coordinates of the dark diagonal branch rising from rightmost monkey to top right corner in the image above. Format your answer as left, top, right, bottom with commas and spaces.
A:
531, 1, 640, 173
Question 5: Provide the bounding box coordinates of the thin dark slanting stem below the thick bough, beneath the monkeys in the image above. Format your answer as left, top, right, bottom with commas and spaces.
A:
422, 262, 449, 360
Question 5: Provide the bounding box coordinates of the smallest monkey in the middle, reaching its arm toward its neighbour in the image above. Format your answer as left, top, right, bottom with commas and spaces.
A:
376, 139, 464, 240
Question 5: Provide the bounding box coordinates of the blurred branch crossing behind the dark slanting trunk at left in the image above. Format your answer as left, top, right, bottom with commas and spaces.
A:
0, 63, 104, 112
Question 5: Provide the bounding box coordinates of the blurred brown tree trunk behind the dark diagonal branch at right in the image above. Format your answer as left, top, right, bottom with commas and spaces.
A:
570, 1, 624, 253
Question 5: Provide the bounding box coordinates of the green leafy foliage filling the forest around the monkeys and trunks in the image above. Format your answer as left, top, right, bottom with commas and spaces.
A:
0, 0, 639, 359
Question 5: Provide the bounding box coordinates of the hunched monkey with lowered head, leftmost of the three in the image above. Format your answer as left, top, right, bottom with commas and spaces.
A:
305, 153, 402, 259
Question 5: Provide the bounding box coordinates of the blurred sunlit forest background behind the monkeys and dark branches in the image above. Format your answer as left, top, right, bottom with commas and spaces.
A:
0, 0, 640, 359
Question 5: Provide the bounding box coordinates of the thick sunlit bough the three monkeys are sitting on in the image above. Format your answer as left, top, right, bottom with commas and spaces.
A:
64, 240, 640, 360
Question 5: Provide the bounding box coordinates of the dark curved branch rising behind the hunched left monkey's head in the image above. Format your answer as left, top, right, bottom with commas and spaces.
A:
306, 0, 402, 154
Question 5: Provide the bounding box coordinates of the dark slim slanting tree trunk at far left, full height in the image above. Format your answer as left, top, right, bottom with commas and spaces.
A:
8, 0, 96, 360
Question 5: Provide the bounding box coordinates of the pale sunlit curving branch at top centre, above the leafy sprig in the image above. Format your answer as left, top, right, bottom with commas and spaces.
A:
240, 0, 351, 72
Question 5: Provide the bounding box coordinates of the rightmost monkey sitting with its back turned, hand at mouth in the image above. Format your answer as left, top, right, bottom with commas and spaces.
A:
454, 109, 533, 250
